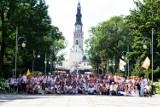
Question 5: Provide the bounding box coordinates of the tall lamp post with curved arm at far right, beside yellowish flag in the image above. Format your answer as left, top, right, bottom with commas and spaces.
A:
142, 28, 154, 82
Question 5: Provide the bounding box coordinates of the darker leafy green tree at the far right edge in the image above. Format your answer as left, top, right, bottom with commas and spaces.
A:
126, 0, 160, 71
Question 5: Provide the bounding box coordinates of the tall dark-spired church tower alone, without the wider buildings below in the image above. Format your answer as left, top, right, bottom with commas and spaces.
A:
69, 2, 83, 63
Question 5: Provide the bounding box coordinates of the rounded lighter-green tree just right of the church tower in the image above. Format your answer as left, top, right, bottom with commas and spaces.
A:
86, 16, 130, 74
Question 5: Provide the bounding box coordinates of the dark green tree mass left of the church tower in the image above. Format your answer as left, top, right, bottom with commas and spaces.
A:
0, 0, 65, 75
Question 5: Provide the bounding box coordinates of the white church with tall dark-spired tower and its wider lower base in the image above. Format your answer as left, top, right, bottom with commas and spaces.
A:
63, 2, 92, 73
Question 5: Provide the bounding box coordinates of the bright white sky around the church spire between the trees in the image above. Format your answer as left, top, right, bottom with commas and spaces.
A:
45, 0, 135, 58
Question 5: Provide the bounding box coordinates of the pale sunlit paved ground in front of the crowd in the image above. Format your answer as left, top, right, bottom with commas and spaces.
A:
0, 95, 160, 107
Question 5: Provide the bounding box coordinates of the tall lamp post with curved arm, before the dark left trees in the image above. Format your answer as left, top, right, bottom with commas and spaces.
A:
15, 27, 27, 77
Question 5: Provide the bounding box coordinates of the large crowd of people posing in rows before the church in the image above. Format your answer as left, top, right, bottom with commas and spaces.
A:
6, 72, 152, 97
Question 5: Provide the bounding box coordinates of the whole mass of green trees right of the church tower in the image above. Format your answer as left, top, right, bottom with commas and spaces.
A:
86, 0, 160, 79
